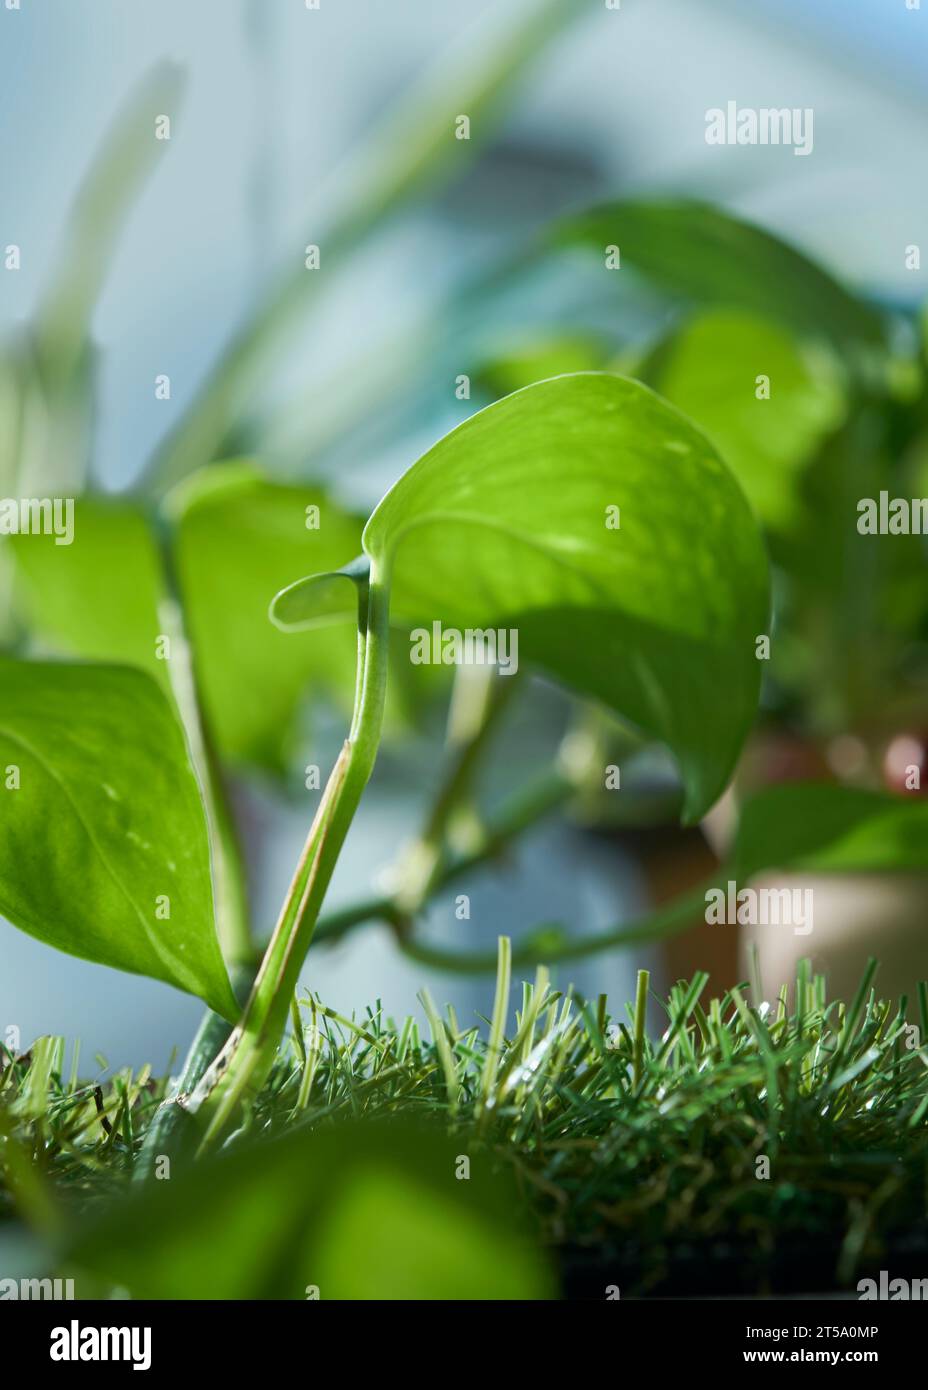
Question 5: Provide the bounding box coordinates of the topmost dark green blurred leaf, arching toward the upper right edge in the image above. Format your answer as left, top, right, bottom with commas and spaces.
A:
552, 200, 885, 352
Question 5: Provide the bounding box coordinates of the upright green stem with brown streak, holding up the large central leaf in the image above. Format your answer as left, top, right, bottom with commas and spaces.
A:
189, 558, 389, 1150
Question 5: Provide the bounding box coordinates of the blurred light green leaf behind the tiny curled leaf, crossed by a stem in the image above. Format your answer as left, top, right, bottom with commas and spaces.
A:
10, 463, 383, 773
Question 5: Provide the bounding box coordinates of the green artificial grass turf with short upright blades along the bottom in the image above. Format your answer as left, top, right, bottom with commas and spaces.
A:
0, 949, 928, 1297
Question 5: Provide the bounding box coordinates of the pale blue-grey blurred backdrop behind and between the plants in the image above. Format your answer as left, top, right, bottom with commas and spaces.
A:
0, 0, 928, 1065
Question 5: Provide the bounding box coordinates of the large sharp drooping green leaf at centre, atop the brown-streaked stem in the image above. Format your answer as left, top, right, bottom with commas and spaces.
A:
347, 373, 767, 819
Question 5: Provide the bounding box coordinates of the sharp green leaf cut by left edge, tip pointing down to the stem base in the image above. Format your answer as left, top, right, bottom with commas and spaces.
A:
0, 659, 238, 1019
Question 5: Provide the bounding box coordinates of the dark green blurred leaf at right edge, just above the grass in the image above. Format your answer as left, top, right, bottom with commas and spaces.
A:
732, 783, 928, 877
